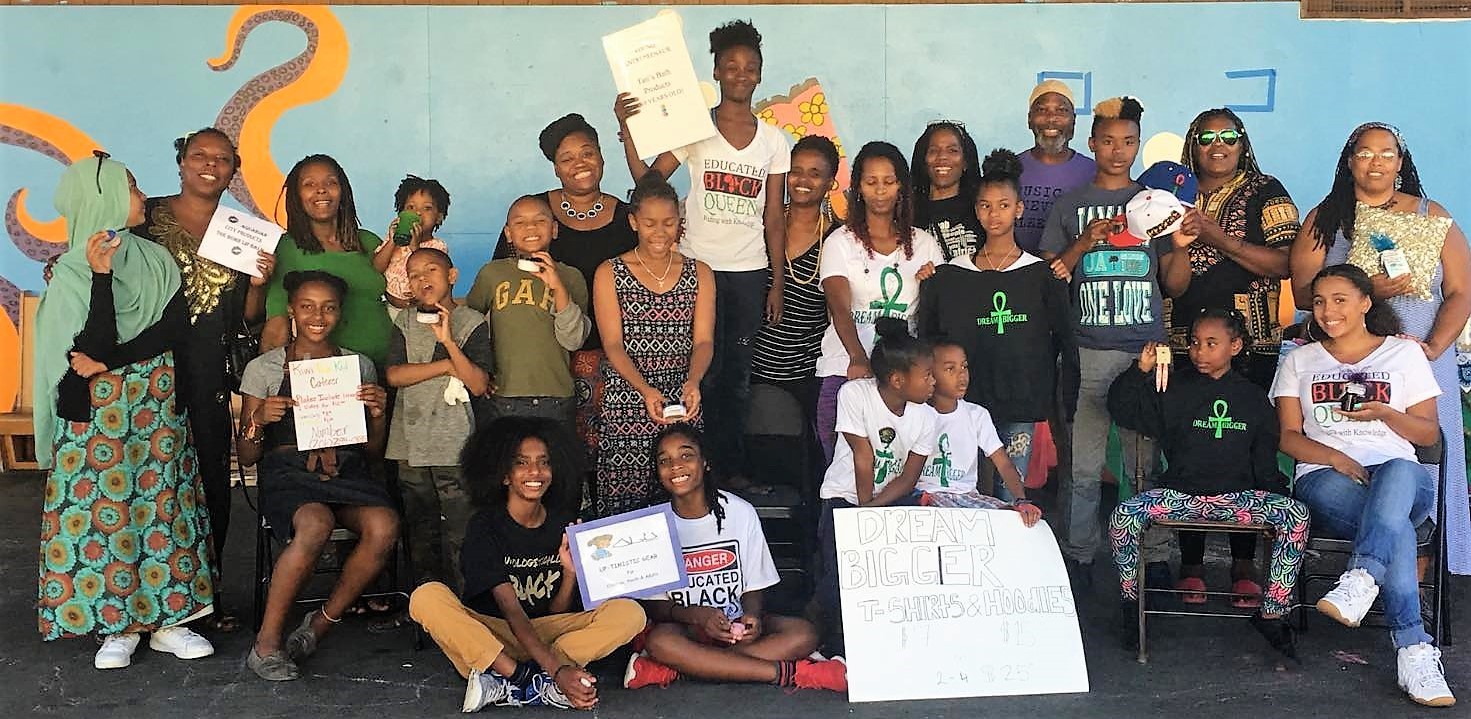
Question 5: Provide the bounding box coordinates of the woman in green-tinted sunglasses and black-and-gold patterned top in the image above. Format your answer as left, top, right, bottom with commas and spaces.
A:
1169, 107, 1299, 388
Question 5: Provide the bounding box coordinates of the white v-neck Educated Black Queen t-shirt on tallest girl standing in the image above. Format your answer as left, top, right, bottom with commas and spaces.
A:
674, 121, 791, 272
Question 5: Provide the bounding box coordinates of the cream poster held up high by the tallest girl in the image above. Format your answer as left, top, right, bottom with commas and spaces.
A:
603, 10, 715, 157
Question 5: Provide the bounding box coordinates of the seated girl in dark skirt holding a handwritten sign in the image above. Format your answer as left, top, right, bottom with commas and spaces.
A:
235, 271, 399, 681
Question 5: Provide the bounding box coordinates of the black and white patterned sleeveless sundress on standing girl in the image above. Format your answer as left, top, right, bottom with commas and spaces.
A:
593, 257, 700, 518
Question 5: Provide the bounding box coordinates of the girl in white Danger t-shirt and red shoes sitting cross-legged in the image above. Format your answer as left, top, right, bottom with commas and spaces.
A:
624, 422, 847, 691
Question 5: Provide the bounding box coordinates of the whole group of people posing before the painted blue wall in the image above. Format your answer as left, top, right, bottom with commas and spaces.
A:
34, 22, 1471, 712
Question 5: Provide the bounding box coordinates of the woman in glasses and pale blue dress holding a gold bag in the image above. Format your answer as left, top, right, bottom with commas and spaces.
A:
1292, 122, 1471, 575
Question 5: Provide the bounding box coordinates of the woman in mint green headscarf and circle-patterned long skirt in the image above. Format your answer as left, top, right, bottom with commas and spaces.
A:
34, 153, 215, 669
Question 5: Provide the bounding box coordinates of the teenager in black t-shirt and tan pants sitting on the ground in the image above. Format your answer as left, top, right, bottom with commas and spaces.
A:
409, 418, 644, 713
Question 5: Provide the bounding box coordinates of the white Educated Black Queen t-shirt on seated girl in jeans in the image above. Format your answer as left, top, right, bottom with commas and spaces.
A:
1272, 337, 1440, 476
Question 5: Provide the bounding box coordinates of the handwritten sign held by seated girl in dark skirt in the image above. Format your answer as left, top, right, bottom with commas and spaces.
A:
291, 354, 368, 450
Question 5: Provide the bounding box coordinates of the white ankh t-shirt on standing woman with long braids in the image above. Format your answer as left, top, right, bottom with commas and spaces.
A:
818, 226, 944, 374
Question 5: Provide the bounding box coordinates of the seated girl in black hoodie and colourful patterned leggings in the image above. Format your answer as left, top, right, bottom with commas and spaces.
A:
1108, 309, 1308, 659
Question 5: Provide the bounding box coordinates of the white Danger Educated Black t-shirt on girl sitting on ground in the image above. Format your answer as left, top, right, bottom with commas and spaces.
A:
668, 493, 781, 619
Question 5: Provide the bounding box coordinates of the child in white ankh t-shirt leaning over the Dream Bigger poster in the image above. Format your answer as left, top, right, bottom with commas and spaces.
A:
918, 341, 1041, 526
